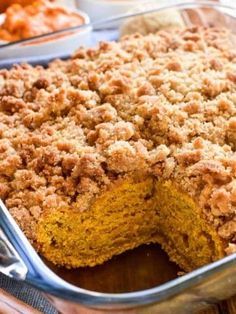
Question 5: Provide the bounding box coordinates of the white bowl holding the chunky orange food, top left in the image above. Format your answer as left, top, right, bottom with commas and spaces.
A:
0, 10, 91, 60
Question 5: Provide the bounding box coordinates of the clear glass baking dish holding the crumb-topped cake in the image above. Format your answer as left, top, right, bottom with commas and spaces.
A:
0, 1, 236, 314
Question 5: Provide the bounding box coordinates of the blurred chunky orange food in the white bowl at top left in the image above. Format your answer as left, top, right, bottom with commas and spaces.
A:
0, 0, 84, 41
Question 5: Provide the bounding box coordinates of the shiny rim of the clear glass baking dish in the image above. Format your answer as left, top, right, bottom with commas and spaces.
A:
0, 0, 236, 307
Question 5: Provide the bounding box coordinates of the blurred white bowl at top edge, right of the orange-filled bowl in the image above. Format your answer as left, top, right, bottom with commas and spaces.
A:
76, 0, 148, 22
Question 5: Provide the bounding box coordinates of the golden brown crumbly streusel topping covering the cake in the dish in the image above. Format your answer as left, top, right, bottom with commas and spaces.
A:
0, 28, 236, 253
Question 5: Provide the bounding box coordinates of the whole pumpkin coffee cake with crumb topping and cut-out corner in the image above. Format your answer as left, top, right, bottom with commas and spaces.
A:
0, 27, 236, 271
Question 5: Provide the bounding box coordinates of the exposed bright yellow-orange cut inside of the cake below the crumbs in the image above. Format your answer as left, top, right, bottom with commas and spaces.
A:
37, 177, 224, 271
